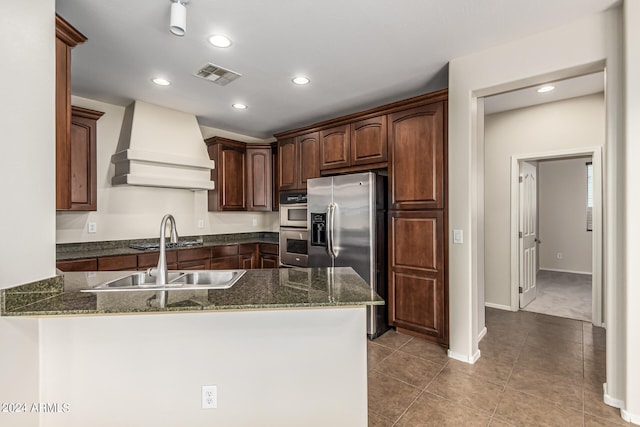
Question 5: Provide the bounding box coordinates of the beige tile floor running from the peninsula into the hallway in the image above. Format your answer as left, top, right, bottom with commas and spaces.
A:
368, 309, 630, 427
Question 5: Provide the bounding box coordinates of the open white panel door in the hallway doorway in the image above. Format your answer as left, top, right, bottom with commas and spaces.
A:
519, 162, 538, 308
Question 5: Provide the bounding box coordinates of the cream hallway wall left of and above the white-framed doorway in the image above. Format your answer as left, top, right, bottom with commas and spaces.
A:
484, 93, 605, 307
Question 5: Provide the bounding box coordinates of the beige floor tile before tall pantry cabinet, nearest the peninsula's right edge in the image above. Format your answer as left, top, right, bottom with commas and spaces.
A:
376, 351, 443, 390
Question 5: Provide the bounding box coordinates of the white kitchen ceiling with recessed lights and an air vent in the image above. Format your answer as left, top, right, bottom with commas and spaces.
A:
56, 0, 618, 138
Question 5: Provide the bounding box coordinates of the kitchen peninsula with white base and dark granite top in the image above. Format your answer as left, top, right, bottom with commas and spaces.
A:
0, 268, 383, 426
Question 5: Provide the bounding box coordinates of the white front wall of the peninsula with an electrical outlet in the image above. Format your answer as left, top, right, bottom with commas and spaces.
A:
41, 307, 367, 427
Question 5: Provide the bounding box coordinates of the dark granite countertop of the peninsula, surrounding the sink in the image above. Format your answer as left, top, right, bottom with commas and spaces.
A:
0, 267, 384, 317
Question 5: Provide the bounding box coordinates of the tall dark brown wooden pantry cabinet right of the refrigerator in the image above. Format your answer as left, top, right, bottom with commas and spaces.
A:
387, 91, 449, 346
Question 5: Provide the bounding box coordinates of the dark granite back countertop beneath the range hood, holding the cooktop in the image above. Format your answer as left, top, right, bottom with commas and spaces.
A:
56, 232, 279, 261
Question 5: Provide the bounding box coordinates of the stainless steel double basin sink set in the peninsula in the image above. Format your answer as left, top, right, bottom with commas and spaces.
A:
82, 270, 246, 292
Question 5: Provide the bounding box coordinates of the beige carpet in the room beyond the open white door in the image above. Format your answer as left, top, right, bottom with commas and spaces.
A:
522, 270, 591, 322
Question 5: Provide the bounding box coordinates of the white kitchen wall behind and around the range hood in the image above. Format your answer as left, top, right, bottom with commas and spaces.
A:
56, 96, 278, 243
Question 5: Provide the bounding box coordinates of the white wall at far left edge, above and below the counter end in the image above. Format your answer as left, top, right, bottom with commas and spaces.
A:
0, 0, 55, 427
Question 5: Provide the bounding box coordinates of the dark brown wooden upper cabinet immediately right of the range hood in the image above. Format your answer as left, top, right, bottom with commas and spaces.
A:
205, 136, 247, 211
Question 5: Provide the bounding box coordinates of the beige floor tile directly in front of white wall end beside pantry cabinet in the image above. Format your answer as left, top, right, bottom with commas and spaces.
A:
427, 368, 503, 414
